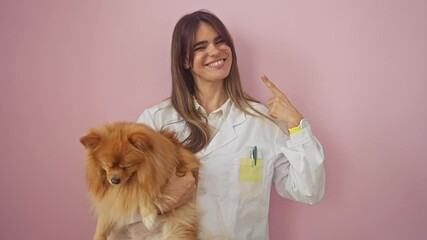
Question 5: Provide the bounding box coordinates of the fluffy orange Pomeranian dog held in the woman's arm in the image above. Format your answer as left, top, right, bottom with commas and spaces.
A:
80, 122, 200, 240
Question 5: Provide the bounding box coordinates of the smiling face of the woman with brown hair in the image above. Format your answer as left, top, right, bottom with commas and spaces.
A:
184, 22, 233, 85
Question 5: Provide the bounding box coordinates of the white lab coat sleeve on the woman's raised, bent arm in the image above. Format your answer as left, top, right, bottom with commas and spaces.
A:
273, 124, 325, 204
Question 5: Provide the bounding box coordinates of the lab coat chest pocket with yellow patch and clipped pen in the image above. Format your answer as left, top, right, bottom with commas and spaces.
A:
235, 147, 263, 202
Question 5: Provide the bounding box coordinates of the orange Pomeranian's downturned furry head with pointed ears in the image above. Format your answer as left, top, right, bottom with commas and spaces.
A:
80, 123, 168, 185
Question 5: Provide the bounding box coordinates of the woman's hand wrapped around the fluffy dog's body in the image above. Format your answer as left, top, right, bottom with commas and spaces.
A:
159, 171, 197, 213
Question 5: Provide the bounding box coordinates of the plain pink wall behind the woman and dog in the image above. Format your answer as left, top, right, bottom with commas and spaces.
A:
0, 0, 427, 240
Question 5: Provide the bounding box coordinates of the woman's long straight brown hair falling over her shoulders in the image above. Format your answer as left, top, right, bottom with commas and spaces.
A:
171, 10, 265, 153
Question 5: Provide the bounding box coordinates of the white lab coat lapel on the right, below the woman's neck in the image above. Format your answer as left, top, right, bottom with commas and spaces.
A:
203, 103, 246, 156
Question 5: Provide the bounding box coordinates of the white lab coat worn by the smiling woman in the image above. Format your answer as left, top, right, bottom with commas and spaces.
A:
138, 100, 325, 240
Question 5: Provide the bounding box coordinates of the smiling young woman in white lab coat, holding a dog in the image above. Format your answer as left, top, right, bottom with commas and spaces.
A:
127, 11, 325, 240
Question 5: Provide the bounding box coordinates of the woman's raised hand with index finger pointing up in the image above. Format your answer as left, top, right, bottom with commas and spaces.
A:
261, 75, 303, 128
